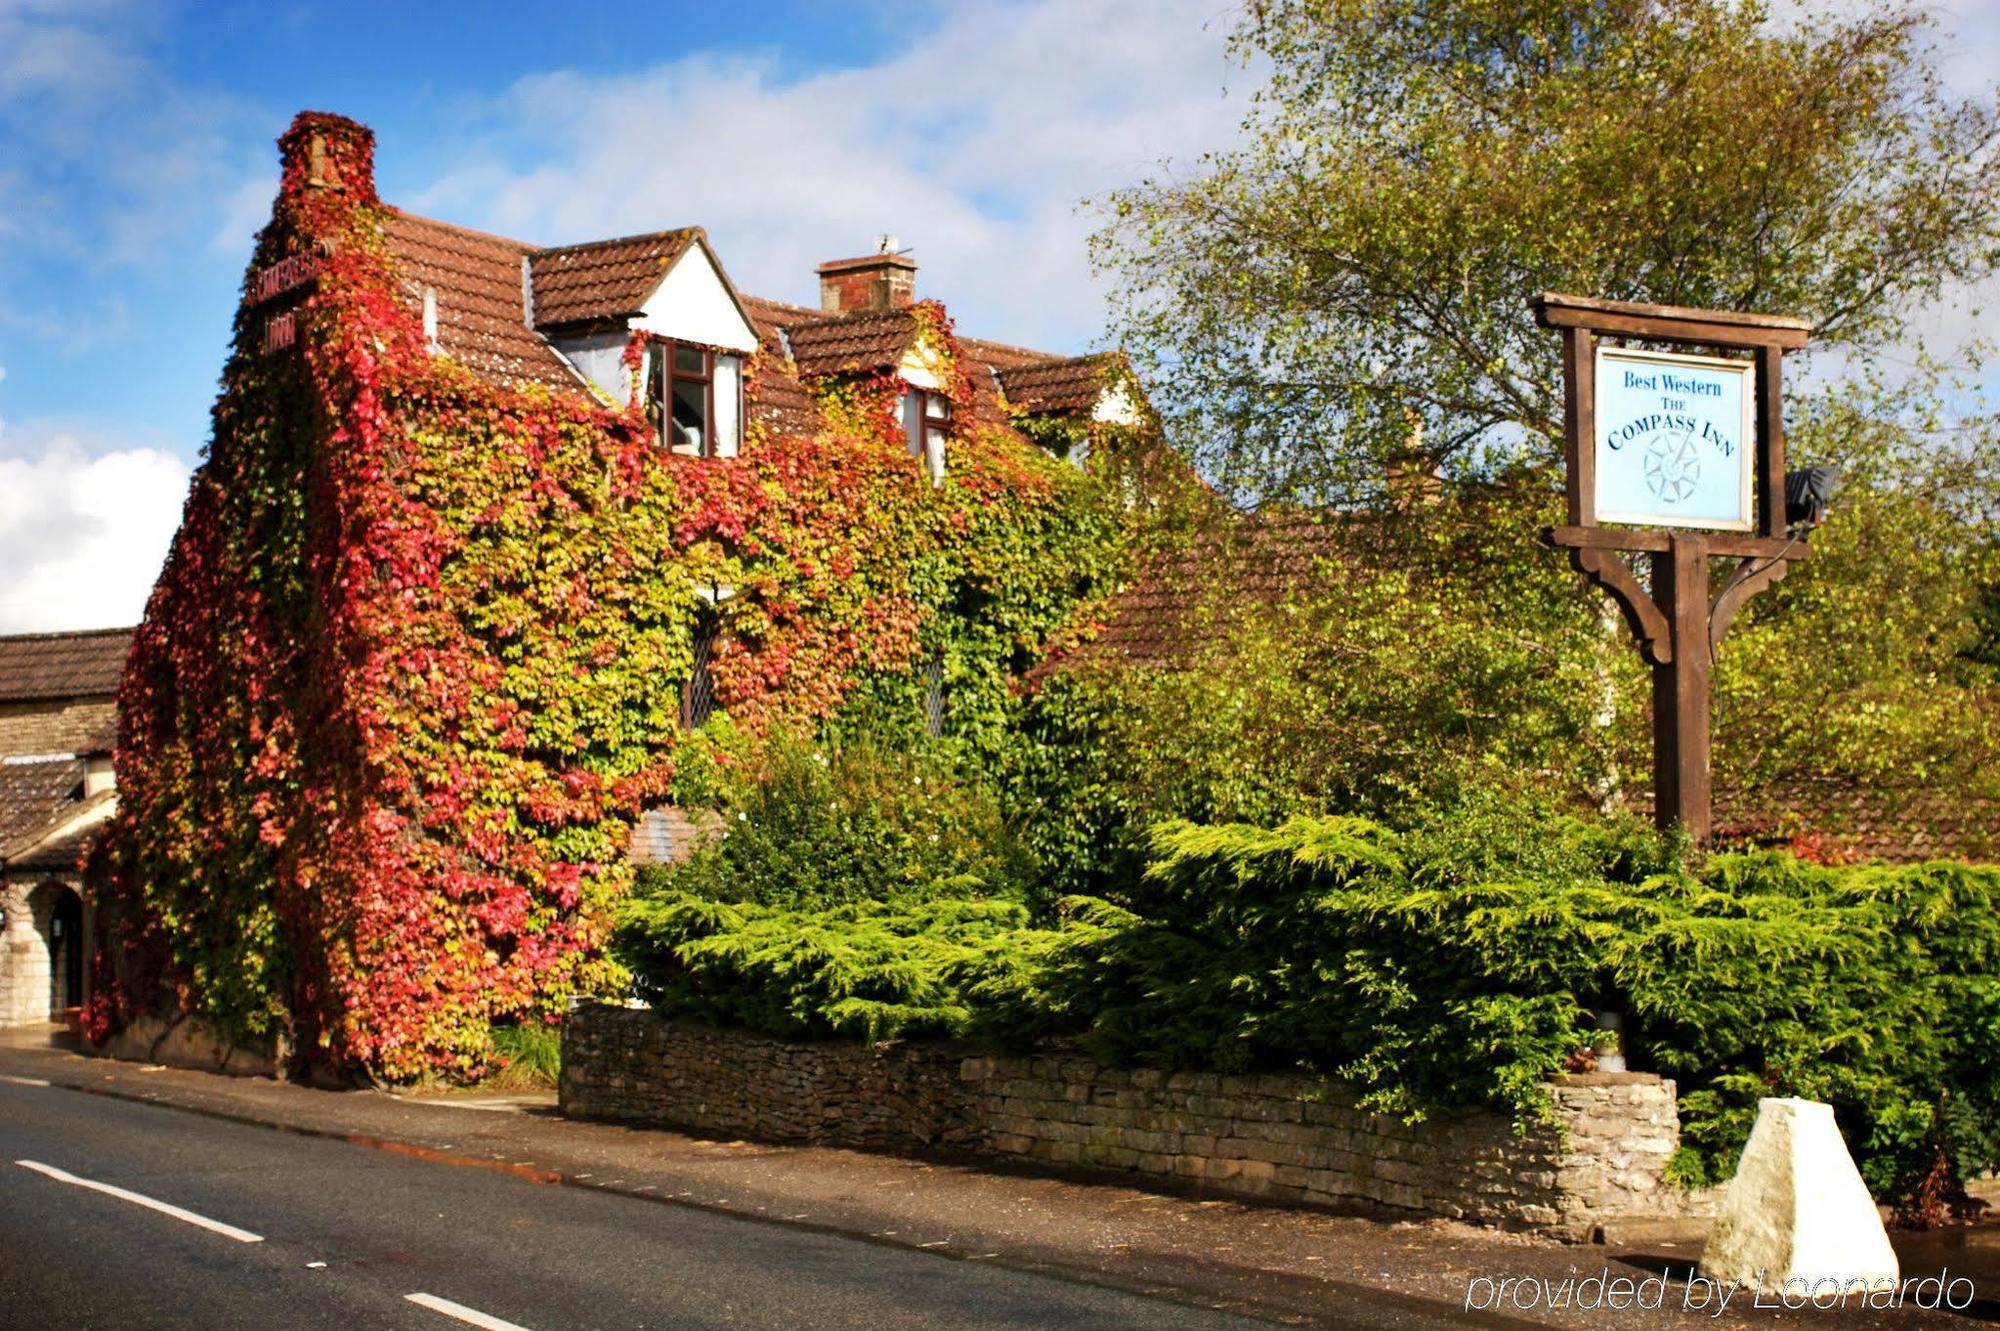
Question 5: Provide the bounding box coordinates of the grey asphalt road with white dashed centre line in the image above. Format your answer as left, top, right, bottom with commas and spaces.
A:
0, 1081, 1304, 1331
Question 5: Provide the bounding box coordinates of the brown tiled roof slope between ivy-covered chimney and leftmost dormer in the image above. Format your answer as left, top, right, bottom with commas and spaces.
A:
382, 212, 580, 388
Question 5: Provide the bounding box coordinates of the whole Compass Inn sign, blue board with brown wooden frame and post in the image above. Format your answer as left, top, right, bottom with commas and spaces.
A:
1530, 292, 1812, 841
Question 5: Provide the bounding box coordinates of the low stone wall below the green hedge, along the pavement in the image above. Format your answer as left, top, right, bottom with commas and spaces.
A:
562, 1005, 1690, 1239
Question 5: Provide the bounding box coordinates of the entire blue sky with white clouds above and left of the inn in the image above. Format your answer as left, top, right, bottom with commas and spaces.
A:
0, 0, 2000, 632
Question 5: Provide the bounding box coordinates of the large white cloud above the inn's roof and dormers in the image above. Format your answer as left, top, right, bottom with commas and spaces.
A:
406, 0, 1242, 348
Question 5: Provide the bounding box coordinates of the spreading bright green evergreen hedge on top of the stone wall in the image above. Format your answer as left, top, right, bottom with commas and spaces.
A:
620, 795, 2000, 1195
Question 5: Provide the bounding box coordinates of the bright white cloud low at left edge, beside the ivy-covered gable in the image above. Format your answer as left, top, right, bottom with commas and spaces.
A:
0, 432, 188, 634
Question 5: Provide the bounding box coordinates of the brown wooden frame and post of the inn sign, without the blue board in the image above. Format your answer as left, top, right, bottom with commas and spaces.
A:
1528, 292, 1812, 841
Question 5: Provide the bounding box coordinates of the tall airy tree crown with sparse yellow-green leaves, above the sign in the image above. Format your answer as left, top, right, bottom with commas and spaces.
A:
1096, 0, 2000, 498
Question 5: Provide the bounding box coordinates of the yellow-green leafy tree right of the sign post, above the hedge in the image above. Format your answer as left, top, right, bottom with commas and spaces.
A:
1704, 376, 2000, 807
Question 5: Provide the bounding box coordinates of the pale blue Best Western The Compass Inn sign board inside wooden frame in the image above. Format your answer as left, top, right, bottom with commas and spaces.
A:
1594, 346, 1756, 532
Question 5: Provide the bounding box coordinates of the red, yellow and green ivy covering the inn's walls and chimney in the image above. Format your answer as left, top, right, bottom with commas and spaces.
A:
88, 114, 1128, 1079
